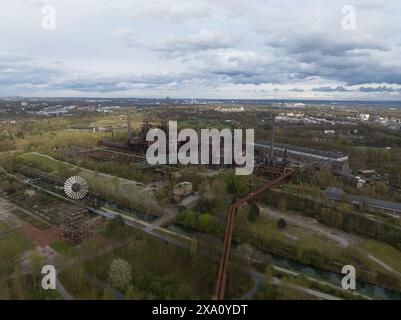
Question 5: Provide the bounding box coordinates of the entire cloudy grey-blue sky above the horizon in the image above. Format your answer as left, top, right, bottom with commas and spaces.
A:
0, 0, 401, 100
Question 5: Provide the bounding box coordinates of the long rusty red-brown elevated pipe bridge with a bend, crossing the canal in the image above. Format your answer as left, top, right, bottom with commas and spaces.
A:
214, 169, 299, 300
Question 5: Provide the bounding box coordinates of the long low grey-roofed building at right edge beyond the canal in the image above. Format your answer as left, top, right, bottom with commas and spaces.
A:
324, 187, 401, 216
